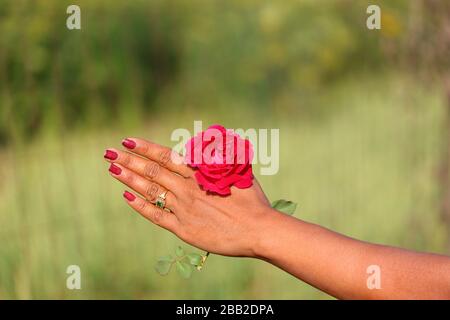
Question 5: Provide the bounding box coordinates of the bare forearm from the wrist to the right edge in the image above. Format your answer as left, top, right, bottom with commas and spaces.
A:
255, 210, 450, 299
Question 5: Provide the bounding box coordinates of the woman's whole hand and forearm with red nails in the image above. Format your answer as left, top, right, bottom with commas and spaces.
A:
105, 138, 450, 299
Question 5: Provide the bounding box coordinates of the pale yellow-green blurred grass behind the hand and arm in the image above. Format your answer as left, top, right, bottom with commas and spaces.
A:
0, 74, 446, 299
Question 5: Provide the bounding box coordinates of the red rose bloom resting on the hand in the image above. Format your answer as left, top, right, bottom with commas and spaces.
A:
185, 125, 253, 196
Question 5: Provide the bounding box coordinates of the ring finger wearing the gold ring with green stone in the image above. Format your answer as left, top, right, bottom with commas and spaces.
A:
109, 164, 177, 211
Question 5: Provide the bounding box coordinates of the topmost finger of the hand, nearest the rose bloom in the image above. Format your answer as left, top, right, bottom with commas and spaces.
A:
122, 138, 194, 178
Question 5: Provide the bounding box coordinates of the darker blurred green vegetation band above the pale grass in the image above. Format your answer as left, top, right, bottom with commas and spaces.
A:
0, 0, 407, 144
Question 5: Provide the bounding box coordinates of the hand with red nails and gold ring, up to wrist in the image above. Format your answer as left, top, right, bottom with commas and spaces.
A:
105, 138, 273, 257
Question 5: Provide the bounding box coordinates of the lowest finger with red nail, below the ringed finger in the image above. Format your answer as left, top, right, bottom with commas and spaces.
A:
123, 191, 179, 233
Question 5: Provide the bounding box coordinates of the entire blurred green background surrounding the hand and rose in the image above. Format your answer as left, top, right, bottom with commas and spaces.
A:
0, 0, 450, 299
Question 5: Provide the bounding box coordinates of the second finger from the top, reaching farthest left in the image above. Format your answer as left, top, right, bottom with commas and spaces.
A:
105, 149, 186, 194
